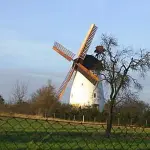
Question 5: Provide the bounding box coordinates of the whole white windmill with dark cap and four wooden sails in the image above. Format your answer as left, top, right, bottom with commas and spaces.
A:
53, 24, 104, 110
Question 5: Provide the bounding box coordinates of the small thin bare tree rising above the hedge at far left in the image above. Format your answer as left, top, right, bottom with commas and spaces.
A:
12, 80, 27, 103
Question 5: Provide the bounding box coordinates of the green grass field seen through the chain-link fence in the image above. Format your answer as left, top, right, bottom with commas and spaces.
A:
0, 117, 150, 150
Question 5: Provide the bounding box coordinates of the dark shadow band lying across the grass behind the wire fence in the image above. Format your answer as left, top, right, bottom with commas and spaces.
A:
0, 131, 150, 142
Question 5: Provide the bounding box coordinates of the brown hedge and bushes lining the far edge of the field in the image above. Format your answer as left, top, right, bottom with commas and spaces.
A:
0, 83, 150, 127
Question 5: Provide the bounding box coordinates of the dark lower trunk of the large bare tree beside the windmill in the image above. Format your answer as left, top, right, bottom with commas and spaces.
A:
106, 106, 113, 138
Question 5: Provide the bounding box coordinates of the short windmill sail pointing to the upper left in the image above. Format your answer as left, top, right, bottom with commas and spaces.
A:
53, 42, 75, 61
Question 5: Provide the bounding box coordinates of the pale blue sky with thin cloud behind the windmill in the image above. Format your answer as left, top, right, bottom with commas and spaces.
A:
0, 0, 150, 102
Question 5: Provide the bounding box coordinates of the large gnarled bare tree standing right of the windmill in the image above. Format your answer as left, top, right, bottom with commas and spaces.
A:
95, 35, 150, 137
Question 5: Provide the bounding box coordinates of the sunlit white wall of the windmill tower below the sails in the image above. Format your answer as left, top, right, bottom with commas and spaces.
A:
70, 71, 100, 106
